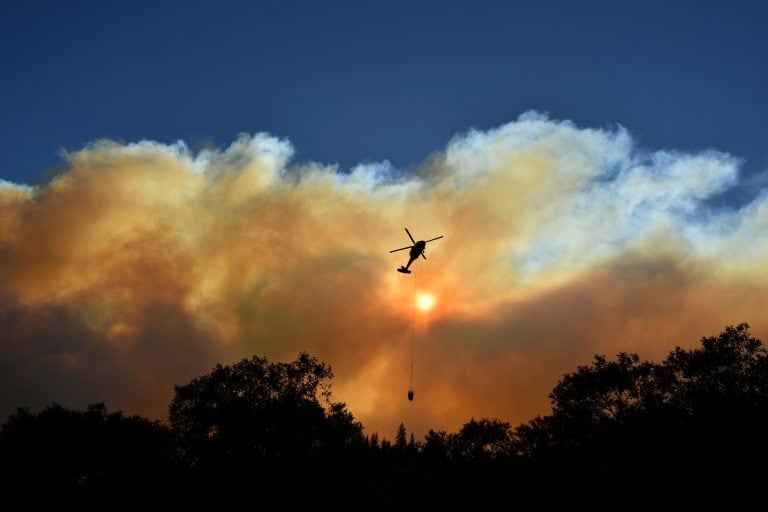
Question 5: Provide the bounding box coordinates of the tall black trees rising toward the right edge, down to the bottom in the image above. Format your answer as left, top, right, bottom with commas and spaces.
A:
513, 324, 768, 505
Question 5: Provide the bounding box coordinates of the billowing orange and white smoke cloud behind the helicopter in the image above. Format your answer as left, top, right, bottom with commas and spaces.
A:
0, 112, 768, 438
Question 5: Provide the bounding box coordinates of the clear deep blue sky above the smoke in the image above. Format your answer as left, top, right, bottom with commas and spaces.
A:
0, 0, 768, 199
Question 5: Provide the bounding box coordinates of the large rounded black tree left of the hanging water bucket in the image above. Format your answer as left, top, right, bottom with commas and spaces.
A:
170, 353, 364, 508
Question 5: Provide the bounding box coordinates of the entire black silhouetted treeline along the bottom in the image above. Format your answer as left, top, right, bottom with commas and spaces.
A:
0, 324, 768, 510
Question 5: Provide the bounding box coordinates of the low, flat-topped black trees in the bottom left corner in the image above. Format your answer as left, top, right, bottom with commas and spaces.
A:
0, 403, 175, 508
